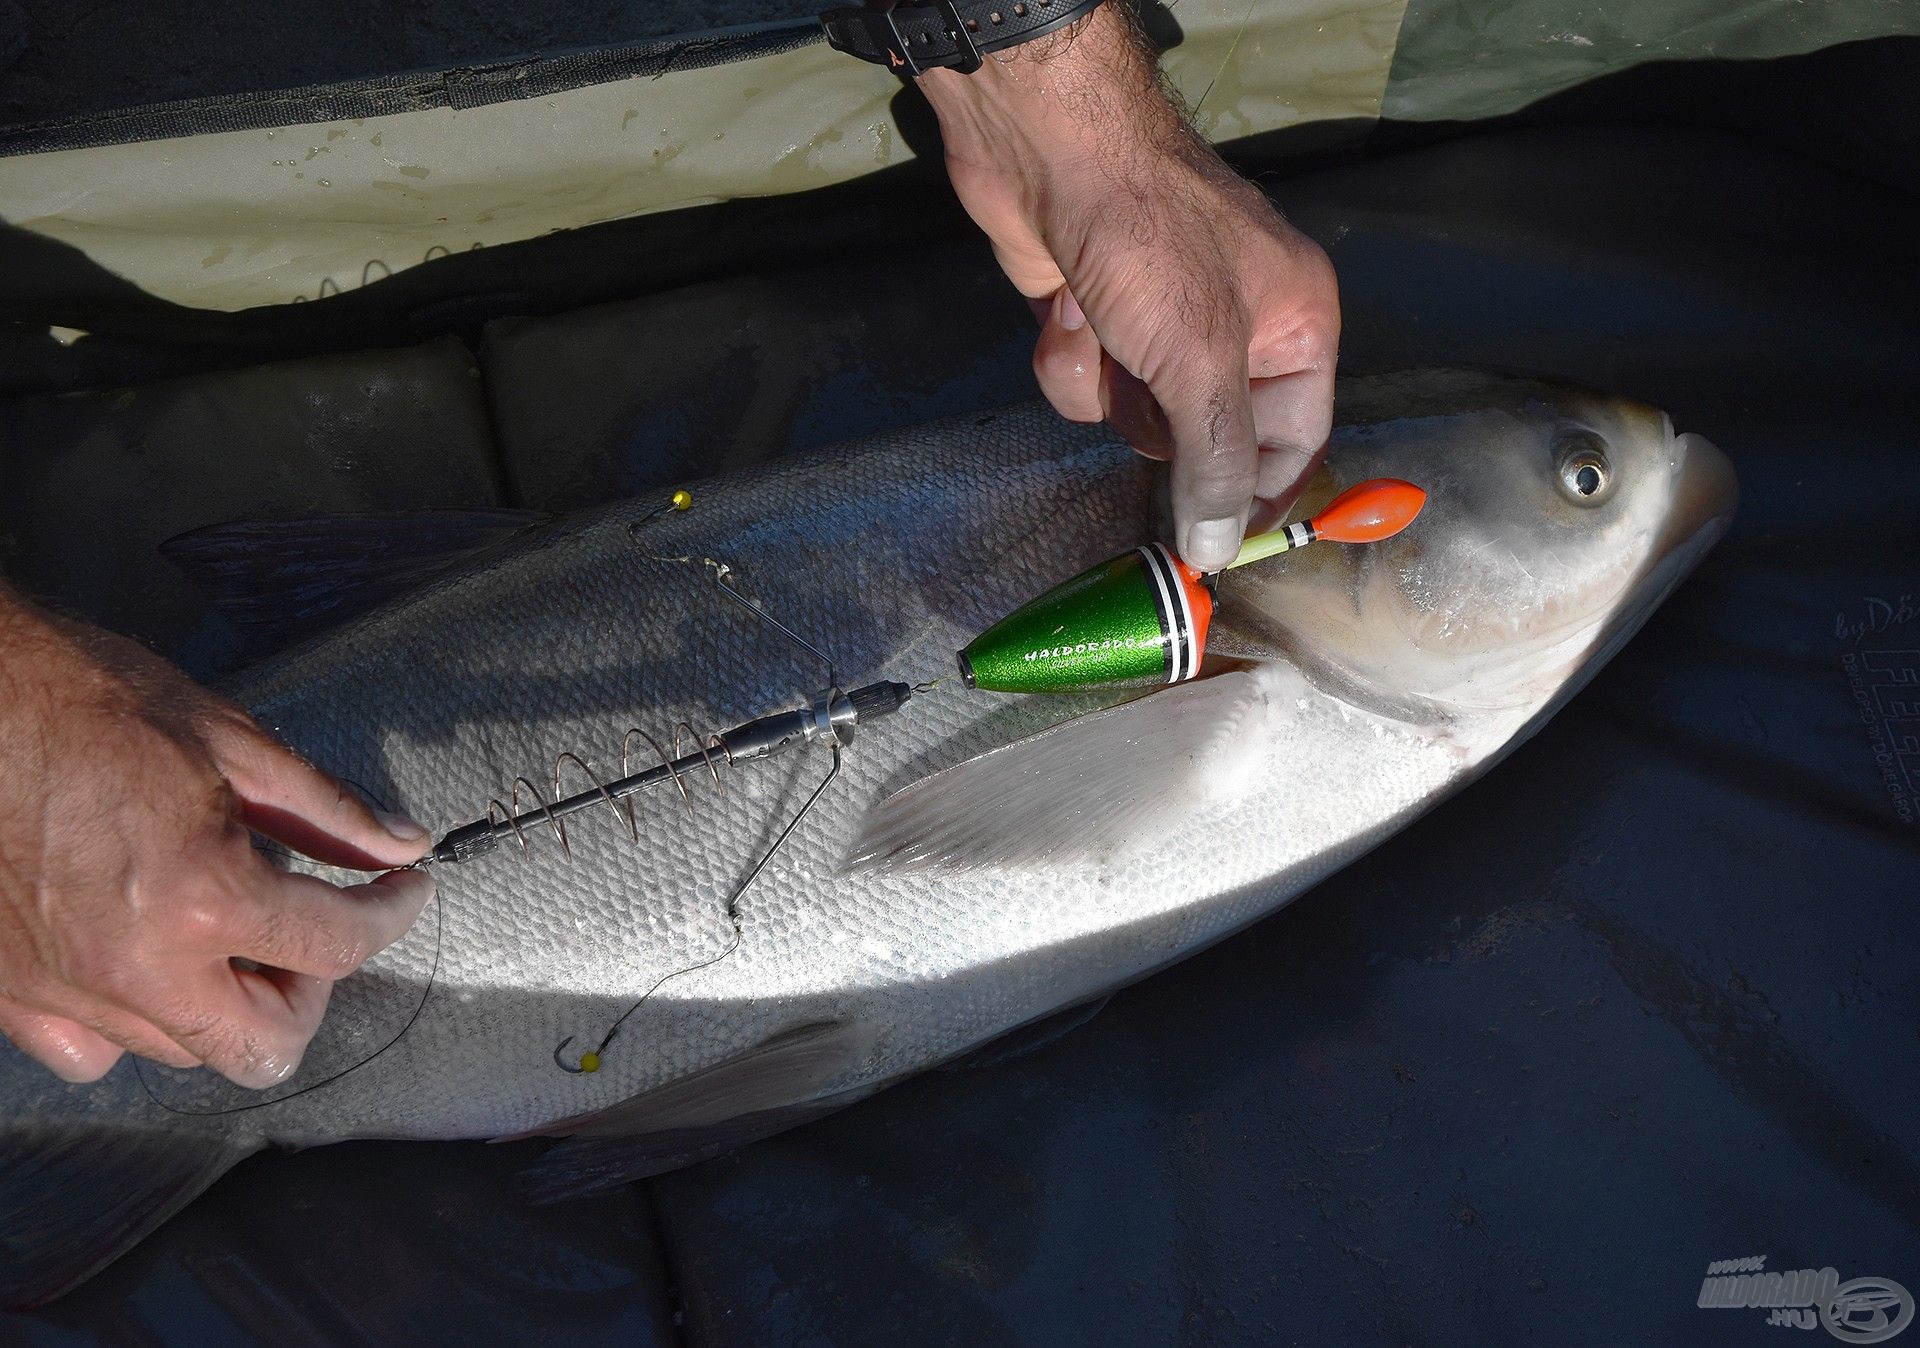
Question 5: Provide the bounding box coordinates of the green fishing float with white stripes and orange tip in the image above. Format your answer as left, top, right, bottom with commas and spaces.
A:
960, 478, 1427, 693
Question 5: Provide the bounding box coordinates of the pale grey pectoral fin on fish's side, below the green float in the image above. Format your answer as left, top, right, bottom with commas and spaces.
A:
847, 670, 1267, 872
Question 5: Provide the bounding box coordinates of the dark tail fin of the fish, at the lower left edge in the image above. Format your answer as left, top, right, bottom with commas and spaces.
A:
0, 1121, 252, 1310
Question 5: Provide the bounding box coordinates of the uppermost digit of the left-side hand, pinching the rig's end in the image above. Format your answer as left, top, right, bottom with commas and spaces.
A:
207, 709, 430, 870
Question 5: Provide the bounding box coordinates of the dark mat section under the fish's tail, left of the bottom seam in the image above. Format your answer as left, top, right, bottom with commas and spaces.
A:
0, 1143, 676, 1348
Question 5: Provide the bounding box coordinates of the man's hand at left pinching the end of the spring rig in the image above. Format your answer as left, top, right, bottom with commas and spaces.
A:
0, 588, 434, 1087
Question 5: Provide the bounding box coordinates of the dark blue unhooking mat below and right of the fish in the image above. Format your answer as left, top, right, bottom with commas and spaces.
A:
0, 129, 1920, 1346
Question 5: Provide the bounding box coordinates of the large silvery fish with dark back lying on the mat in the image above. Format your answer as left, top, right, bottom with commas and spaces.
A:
0, 371, 1738, 1306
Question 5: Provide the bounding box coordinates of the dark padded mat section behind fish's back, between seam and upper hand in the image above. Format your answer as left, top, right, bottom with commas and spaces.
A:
480, 238, 1039, 511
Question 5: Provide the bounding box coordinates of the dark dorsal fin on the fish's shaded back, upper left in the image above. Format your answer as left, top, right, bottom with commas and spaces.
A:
159, 507, 549, 647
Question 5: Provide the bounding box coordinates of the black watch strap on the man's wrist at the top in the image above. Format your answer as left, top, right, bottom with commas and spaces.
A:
820, 0, 1100, 75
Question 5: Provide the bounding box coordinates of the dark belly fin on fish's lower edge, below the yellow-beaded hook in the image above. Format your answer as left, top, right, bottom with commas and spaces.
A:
495, 1022, 874, 1202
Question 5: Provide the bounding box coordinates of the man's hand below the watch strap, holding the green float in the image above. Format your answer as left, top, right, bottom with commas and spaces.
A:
920, 0, 1340, 570
